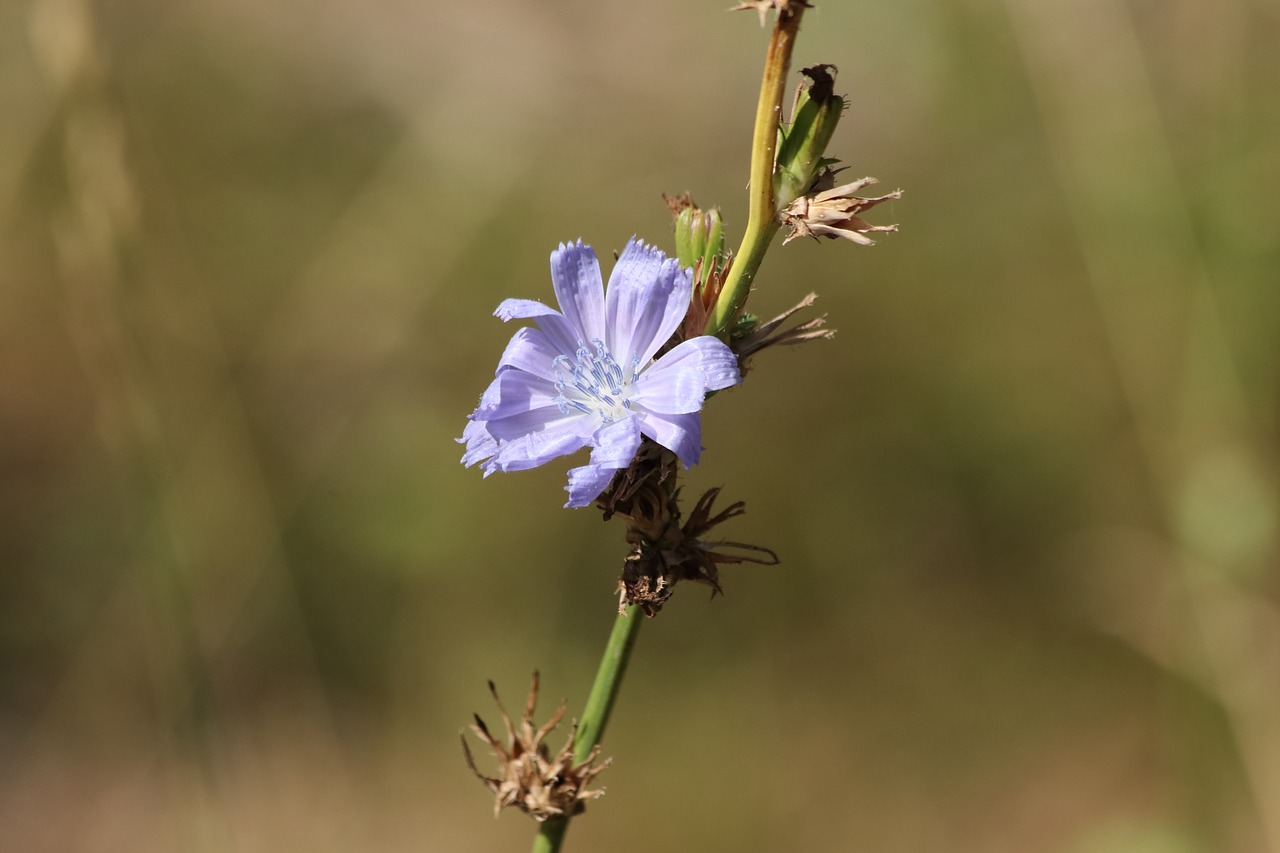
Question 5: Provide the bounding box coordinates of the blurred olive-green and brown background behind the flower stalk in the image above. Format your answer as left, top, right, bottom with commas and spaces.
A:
0, 0, 1280, 853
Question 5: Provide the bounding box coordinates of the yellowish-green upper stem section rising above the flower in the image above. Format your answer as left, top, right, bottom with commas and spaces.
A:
705, 4, 804, 337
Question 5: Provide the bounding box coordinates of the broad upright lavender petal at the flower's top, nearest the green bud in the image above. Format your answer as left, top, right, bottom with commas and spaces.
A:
604, 237, 694, 369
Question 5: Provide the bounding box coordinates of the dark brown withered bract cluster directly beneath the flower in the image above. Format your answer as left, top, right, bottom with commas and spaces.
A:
596, 443, 778, 616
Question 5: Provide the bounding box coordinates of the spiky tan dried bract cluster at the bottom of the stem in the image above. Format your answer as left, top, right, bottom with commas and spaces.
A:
462, 672, 609, 822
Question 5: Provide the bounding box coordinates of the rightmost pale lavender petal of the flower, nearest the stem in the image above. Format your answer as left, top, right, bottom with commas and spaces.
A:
632, 336, 741, 415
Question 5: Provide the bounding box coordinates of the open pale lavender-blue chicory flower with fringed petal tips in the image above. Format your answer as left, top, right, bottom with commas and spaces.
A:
458, 238, 741, 506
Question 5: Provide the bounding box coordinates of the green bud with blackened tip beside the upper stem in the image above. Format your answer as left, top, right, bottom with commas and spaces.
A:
773, 65, 845, 210
